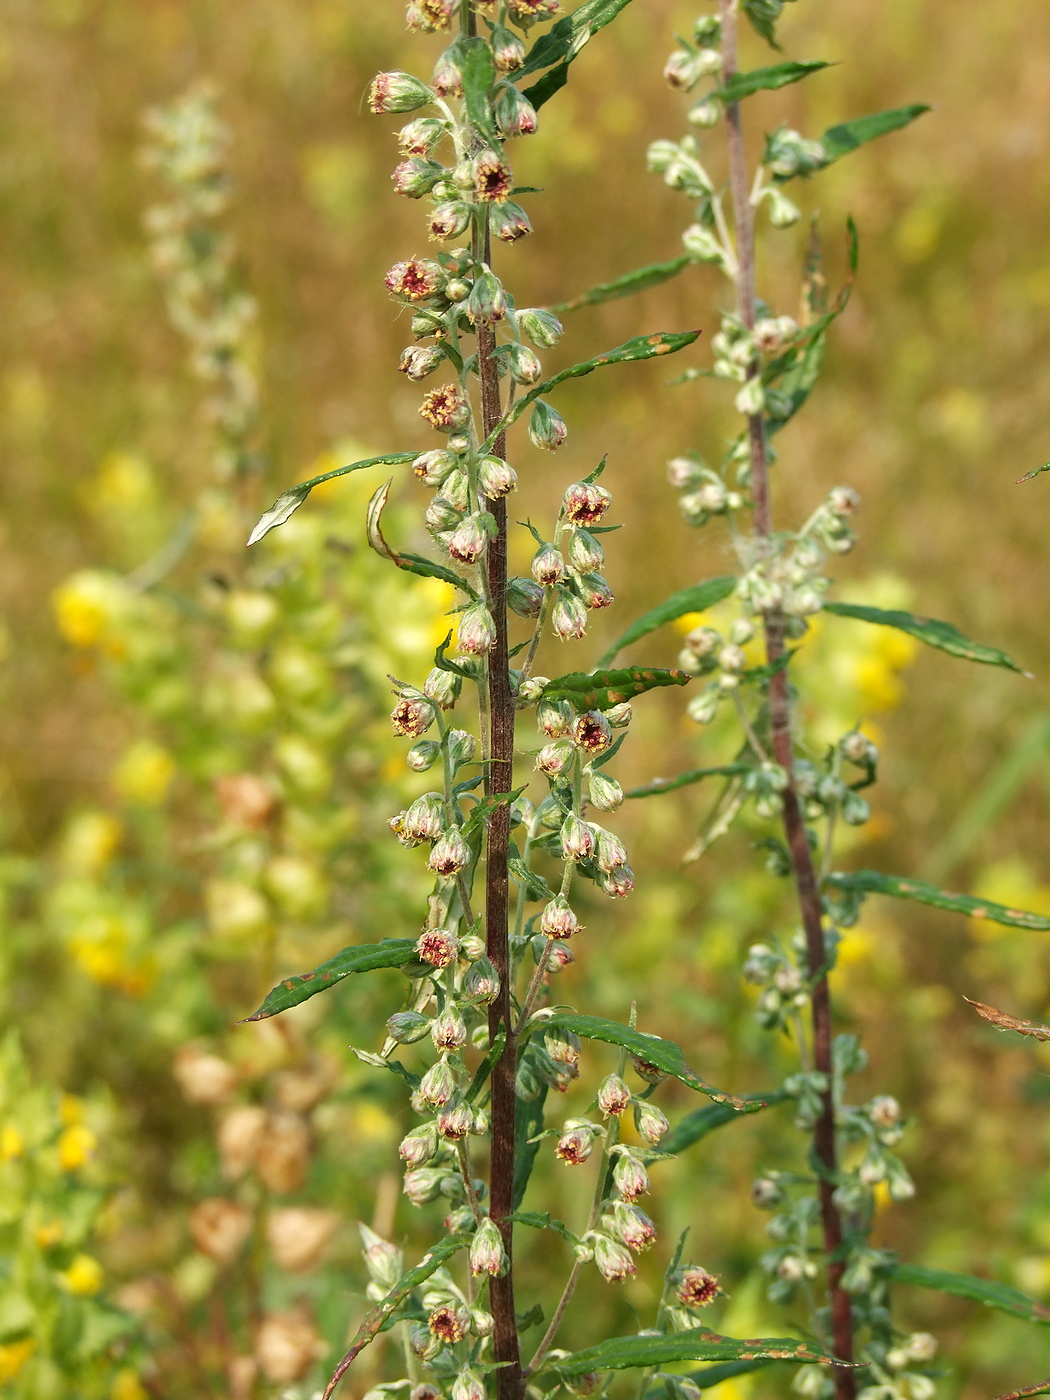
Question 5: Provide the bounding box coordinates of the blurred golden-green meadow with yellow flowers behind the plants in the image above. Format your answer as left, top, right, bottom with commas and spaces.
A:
0, 0, 1050, 1400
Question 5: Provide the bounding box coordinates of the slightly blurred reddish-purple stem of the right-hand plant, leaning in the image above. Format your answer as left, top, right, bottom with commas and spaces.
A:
718, 0, 857, 1383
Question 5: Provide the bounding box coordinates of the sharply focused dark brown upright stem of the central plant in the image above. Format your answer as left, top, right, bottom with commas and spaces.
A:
469, 158, 522, 1400
